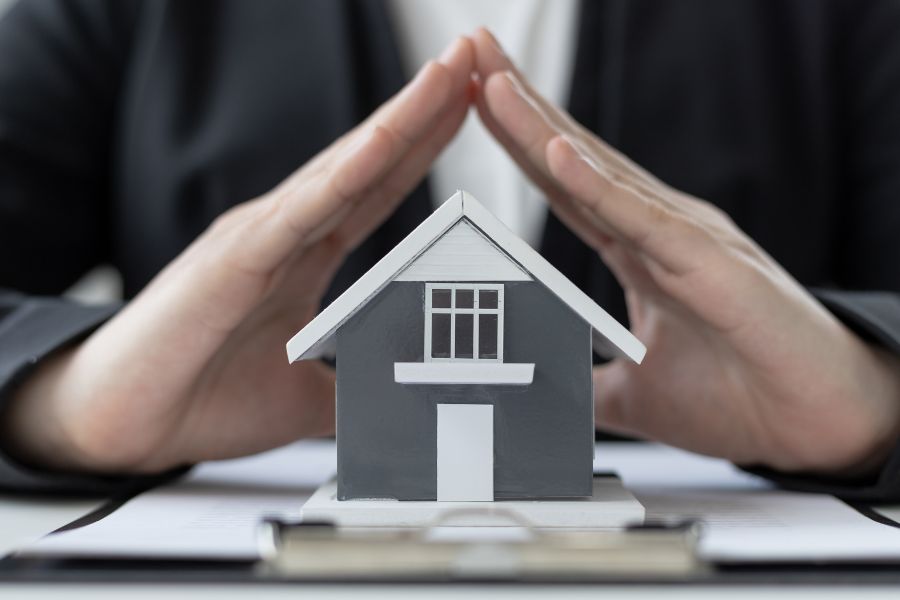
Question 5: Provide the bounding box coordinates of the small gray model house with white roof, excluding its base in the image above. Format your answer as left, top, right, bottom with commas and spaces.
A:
287, 192, 645, 501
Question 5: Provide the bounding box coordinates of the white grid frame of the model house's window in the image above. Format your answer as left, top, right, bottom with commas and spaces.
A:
425, 282, 503, 363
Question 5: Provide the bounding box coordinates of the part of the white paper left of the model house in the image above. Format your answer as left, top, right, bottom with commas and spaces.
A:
20, 440, 336, 560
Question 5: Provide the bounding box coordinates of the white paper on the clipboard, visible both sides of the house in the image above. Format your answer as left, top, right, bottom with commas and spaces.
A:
25, 442, 900, 561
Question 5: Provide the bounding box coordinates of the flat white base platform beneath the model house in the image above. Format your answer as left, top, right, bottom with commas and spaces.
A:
301, 477, 644, 529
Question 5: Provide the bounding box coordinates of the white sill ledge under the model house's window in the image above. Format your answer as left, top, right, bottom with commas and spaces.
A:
394, 362, 534, 385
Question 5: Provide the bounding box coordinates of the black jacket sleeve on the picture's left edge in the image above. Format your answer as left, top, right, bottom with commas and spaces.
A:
0, 0, 142, 492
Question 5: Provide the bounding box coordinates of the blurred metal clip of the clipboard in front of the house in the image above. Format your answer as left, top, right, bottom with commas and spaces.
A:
258, 509, 711, 582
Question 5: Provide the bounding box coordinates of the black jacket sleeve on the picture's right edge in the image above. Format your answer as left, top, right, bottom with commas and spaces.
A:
752, 0, 900, 501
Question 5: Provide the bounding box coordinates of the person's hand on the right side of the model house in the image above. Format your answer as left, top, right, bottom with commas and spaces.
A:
473, 30, 900, 474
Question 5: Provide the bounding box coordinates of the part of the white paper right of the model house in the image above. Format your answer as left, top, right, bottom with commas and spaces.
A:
594, 444, 900, 562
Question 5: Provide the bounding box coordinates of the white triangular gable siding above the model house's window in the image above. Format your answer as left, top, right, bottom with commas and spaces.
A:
394, 219, 531, 281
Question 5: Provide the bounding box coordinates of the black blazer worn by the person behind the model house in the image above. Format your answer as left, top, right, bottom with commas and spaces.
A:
0, 0, 900, 497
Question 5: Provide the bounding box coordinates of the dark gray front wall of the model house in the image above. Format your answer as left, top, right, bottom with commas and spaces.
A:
337, 282, 594, 500
